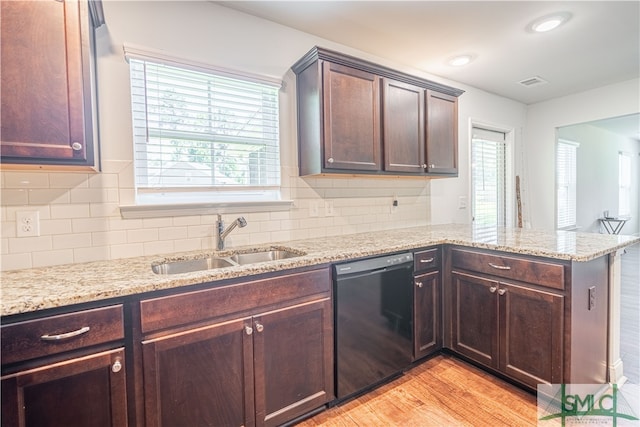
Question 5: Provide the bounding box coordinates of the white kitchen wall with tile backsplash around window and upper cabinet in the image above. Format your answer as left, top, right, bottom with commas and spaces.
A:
0, 1, 536, 270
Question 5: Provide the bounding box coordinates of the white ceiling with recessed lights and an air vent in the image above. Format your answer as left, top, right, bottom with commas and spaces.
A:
217, 0, 640, 138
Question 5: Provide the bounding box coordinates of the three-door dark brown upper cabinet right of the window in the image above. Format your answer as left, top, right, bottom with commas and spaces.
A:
292, 47, 463, 176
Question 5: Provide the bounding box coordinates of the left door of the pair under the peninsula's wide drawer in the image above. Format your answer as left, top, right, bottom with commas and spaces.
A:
452, 272, 498, 368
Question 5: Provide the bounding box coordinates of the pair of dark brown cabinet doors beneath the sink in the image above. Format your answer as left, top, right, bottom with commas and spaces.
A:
142, 298, 333, 427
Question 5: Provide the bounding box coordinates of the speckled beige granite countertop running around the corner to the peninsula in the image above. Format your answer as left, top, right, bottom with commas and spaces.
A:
0, 224, 640, 316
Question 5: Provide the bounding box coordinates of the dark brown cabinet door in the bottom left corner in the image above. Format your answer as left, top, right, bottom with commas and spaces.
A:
2, 349, 127, 427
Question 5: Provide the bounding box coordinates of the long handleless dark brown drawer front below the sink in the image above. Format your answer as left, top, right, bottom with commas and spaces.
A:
140, 268, 331, 333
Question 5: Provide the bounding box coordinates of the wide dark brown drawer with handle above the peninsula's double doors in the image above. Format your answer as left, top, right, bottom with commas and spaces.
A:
451, 249, 565, 289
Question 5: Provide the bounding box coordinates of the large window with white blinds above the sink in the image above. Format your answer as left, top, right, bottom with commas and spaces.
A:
128, 51, 280, 203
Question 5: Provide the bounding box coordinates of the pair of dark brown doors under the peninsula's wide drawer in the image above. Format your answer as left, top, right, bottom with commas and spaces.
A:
452, 271, 564, 388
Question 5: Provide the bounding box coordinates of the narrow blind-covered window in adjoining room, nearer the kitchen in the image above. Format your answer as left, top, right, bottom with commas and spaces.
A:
556, 139, 580, 229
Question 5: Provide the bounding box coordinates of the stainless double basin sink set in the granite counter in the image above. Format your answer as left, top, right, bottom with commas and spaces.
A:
151, 248, 306, 274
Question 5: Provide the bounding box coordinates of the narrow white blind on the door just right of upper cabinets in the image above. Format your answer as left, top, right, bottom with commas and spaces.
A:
471, 127, 508, 228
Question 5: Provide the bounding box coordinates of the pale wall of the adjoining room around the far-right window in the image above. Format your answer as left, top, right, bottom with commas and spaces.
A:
558, 124, 640, 234
